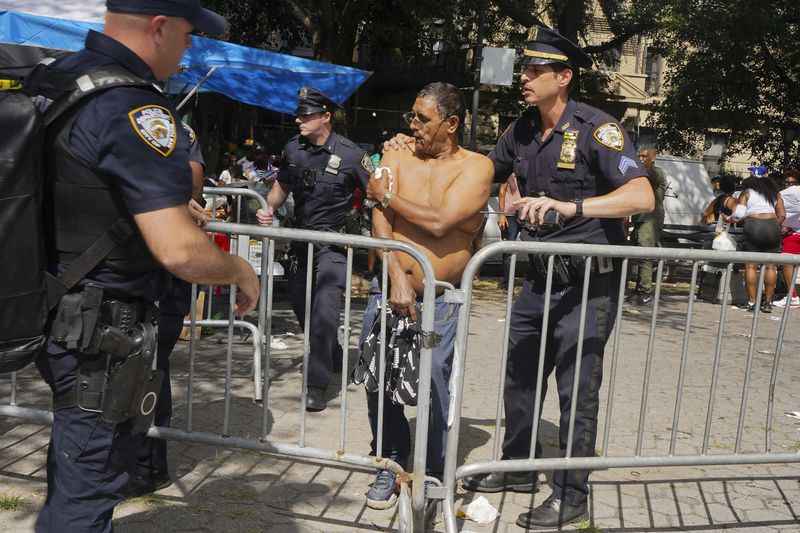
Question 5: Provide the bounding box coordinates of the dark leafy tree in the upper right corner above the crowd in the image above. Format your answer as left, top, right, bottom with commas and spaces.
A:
653, 0, 800, 166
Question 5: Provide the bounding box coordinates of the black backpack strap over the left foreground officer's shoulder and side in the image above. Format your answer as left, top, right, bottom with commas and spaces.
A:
39, 67, 158, 310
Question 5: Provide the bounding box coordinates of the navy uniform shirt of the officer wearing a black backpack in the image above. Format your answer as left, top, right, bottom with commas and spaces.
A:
56, 31, 192, 302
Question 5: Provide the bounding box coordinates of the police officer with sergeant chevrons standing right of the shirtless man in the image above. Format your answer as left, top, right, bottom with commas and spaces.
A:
464, 27, 653, 528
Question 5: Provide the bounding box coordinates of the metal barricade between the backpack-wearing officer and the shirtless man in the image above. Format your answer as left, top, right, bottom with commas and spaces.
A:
195, 222, 436, 531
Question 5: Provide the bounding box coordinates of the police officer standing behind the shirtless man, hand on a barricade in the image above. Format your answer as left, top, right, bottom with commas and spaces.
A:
257, 87, 373, 411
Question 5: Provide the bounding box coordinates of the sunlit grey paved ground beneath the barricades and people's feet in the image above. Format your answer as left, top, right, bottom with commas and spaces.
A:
0, 281, 800, 533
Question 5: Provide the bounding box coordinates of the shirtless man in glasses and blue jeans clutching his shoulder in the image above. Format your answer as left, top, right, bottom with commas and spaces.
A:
362, 83, 494, 509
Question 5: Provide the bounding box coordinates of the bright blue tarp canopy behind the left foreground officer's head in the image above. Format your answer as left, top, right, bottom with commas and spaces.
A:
0, 11, 372, 114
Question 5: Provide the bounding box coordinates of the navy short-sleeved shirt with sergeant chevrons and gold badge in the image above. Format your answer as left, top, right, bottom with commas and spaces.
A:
489, 100, 645, 244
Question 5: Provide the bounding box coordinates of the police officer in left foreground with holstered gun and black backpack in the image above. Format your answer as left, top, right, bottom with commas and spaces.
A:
36, 0, 259, 532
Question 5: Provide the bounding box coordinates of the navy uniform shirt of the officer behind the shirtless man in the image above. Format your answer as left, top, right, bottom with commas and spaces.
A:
278, 132, 374, 231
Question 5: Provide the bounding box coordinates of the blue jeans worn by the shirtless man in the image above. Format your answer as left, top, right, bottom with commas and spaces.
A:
359, 294, 460, 478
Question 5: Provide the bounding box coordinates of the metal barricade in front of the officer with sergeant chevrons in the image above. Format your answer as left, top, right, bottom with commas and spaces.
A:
438, 242, 800, 532
